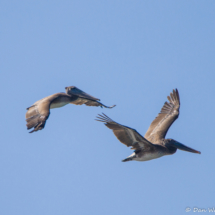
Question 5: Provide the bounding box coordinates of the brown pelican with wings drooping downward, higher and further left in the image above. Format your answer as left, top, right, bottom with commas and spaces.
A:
25, 86, 116, 133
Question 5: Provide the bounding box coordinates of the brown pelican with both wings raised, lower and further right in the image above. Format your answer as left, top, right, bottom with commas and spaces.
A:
96, 89, 201, 162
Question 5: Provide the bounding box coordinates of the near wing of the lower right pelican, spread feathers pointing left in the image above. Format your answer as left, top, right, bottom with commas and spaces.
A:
96, 113, 154, 151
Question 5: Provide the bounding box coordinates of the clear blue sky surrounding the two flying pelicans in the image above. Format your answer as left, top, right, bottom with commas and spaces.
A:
0, 0, 215, 215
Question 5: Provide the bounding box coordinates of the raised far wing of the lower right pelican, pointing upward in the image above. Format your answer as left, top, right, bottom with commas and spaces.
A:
145, 89, 180, 143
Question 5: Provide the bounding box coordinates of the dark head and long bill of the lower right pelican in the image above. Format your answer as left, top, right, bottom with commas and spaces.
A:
165, 139, 201, 154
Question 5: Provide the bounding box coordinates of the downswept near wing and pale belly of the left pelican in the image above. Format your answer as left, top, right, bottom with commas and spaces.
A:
25, 93, 71, 133
